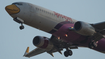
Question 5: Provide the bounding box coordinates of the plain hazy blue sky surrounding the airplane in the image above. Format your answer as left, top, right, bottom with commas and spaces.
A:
0, 0, 105, 59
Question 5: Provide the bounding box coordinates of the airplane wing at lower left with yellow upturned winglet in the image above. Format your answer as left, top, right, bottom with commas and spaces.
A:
24, 35, 78, 57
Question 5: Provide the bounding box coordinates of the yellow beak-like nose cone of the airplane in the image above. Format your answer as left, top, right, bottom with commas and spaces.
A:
5, 5, 20, 15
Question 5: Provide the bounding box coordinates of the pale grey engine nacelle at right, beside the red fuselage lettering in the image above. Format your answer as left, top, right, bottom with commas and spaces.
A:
74, 21, 95, 36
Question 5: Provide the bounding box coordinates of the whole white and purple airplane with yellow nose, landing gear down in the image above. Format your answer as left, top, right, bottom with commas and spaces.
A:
5, 2, 105, 57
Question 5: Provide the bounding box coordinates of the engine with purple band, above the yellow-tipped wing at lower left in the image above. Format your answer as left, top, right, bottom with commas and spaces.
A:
33, 36, 53, 50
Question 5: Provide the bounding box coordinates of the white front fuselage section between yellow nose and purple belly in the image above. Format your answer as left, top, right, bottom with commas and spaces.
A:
11, 3, 76, 32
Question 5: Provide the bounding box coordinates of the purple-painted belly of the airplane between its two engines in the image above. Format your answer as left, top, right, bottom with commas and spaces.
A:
50, 21, 86, 43
